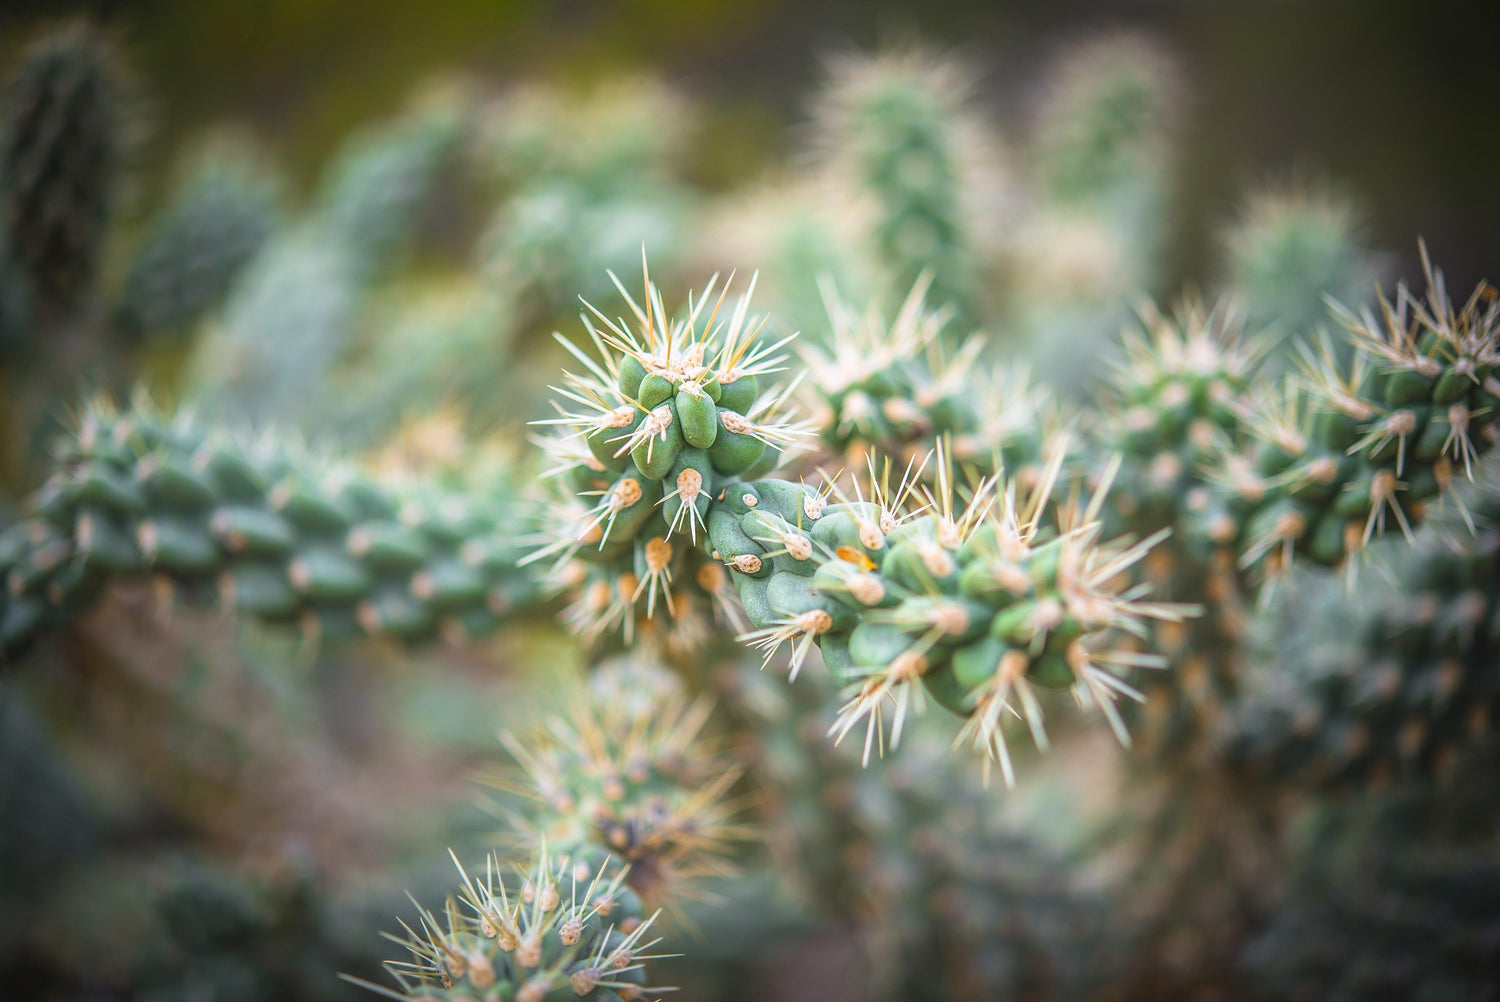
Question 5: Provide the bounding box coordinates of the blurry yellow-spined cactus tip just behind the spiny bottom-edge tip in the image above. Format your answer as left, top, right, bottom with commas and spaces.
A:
504, 659, 741, 906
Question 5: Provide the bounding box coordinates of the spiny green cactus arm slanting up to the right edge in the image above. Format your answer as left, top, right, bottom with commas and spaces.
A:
1199, 255, 1500, 572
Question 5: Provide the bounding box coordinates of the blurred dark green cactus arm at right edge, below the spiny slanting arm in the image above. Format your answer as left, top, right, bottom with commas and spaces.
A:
1226, 479, 1500, 788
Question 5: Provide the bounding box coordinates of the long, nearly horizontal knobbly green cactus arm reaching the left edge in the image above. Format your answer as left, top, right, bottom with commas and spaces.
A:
0, 405, 537, 659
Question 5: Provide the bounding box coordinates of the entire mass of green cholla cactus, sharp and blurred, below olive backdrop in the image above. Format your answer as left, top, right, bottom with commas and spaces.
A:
0, 13, 1500, 1002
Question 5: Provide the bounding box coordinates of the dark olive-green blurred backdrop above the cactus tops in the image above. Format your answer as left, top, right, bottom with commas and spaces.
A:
0, 0, 1500, 288
